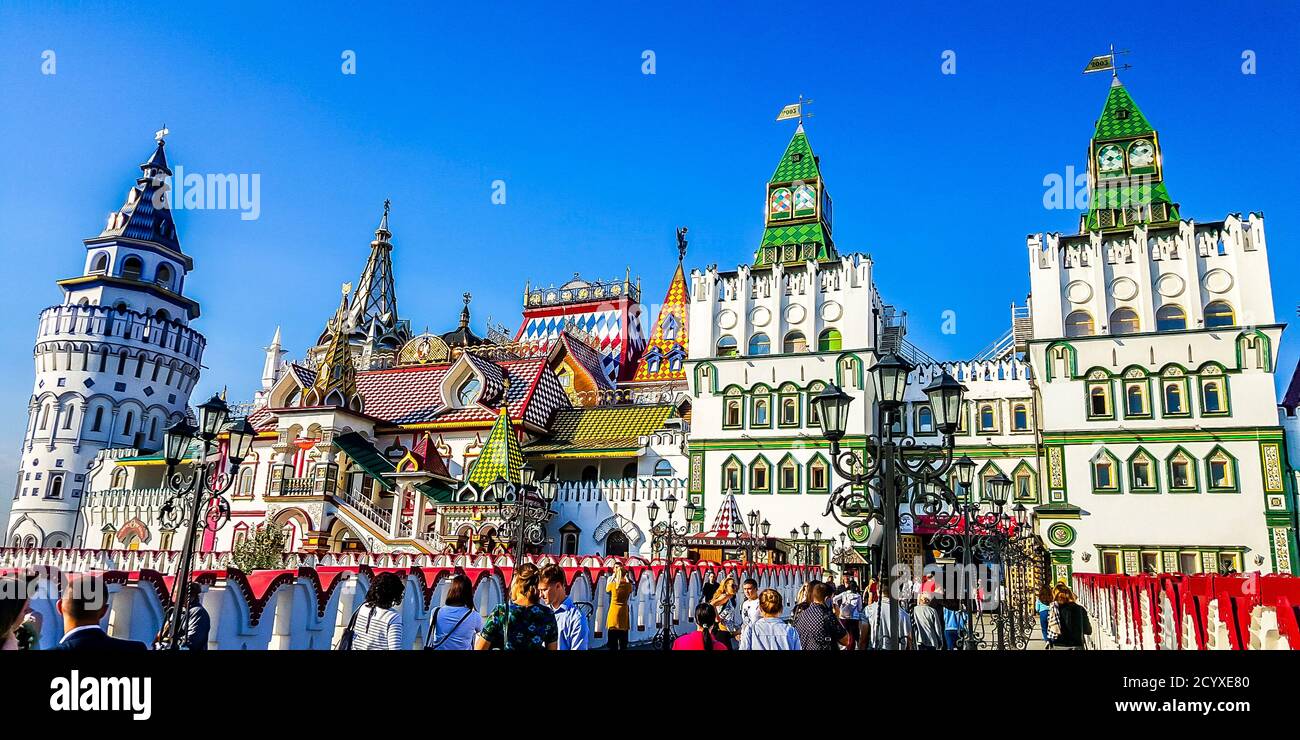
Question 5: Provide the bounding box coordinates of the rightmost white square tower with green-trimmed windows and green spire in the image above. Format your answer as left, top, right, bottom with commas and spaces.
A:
1028, 79, 1296, 577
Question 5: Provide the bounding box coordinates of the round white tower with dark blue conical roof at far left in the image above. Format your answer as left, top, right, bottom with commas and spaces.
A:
5, 130, 205, 548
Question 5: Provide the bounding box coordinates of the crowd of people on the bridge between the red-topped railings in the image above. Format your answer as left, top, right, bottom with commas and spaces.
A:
0, 563, 1092, 650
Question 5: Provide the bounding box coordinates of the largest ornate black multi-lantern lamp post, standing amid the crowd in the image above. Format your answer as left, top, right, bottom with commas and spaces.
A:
813, 354, 966, 649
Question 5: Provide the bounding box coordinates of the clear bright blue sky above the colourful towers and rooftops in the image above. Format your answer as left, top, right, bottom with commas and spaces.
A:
0, 1, 1300, 499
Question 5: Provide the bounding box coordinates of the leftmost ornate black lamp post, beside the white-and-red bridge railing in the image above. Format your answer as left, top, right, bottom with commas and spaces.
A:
159, 395, 257, 650
